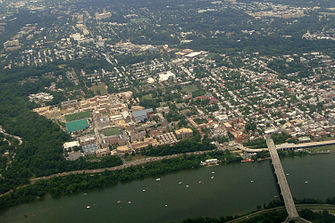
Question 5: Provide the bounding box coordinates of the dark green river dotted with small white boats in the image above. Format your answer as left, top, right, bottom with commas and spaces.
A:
0, 153, 335, 223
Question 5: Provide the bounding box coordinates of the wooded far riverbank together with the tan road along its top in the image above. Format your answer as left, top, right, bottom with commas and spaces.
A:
0, 147, 320, 212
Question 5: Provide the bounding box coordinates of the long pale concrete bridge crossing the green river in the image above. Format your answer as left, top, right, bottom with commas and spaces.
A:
265, 135, 309, 222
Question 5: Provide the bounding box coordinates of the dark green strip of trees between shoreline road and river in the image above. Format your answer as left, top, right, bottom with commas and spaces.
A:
0, 146, 330, 213
